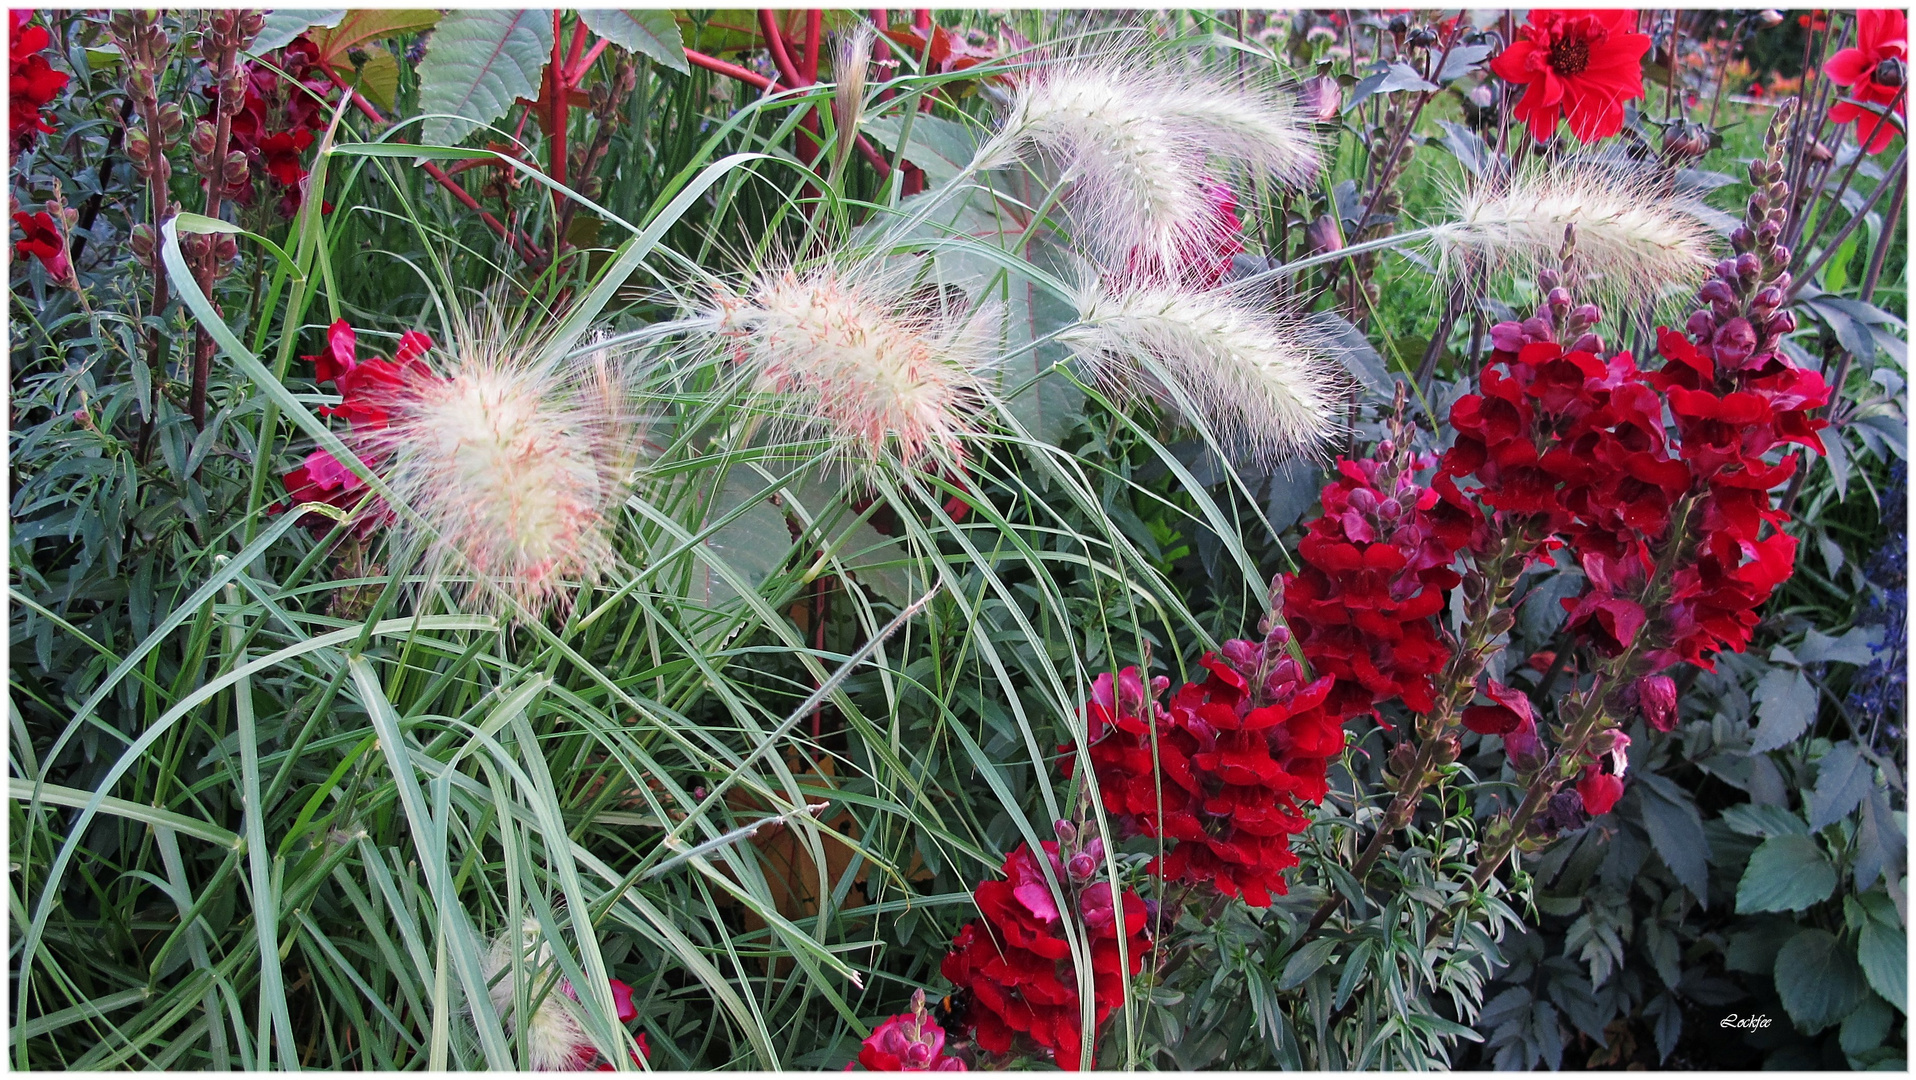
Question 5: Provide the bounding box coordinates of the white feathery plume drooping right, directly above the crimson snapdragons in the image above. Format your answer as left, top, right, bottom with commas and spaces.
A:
1060, 281, 1345, 461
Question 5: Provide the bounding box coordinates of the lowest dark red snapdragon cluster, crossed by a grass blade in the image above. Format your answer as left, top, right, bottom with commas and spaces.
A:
943, 838, 1150, 1069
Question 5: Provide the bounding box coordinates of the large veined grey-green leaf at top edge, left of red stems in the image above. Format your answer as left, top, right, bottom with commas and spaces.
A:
420, 10, 552, 146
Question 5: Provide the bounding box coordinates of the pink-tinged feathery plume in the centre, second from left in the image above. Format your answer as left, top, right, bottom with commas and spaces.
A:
713, 264, 996, 461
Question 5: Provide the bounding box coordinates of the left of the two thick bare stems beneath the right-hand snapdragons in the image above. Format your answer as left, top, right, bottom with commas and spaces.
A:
1305, 517, 1546, 936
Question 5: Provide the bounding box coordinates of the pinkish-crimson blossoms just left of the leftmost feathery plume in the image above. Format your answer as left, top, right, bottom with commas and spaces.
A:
268, 320, 433, 538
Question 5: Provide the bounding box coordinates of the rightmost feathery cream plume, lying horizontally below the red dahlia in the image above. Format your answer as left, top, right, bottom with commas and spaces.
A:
1431, 163, 1719, 299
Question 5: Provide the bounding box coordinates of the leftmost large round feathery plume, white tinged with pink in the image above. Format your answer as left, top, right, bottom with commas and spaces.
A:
370, 326, 638, 611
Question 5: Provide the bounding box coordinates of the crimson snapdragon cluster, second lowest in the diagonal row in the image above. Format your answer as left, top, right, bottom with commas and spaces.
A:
1065, 647, 1343, 908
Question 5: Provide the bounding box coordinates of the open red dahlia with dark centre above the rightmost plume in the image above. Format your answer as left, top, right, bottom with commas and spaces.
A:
1491, 10, 1650, 142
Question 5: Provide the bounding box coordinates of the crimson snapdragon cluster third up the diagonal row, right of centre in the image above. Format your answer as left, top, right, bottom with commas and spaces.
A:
1284, 451, 1481, 720
